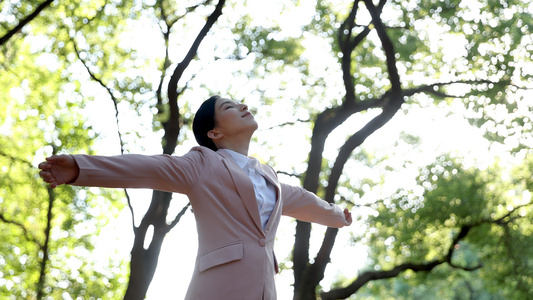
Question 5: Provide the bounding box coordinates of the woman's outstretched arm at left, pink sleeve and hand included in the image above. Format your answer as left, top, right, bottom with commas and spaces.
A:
39, 147, 210, 193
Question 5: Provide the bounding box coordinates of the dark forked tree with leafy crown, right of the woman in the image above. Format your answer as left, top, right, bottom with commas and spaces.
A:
240, 1, 531, 299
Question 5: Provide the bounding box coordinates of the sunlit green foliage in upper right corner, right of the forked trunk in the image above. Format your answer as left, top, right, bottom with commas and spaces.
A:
378, 0, 533, 152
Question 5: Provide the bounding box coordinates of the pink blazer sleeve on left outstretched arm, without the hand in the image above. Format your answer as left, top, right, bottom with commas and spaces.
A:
72, 148, 206, 194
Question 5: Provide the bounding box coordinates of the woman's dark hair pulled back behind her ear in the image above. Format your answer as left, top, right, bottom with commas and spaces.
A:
192, 95, 220, 151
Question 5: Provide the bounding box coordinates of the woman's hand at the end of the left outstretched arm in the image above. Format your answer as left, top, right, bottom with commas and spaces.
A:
39, 155, 80, 188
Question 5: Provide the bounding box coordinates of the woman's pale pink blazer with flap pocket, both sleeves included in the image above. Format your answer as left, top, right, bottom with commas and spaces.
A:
73, 147, 346, 300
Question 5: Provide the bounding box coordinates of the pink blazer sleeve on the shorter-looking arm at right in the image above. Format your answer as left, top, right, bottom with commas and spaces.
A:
280, 183, 348, 228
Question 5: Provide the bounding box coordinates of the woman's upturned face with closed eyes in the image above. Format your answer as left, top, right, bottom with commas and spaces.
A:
214, 98, 258, 137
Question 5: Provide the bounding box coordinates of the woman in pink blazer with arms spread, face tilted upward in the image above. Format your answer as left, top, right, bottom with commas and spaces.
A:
39, 96, 352, 300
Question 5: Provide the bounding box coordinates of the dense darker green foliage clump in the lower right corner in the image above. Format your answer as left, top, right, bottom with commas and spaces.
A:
363, 156, 533, 299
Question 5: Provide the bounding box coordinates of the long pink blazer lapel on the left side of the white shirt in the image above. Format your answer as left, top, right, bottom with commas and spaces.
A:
217, 149, 263, 232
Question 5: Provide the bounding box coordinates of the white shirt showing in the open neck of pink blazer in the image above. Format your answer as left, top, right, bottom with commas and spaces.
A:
226, 149, 276, 229
